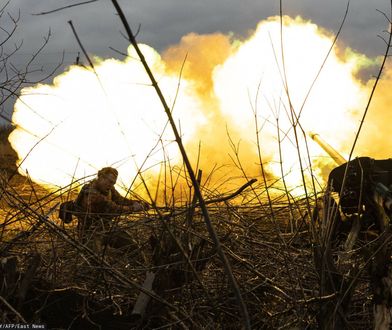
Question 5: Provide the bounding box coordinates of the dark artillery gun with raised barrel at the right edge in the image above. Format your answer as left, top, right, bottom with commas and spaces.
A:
310, 133, 392, 329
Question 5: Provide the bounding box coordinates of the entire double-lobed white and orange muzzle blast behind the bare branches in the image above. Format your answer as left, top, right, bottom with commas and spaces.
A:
10, 17, 384, 196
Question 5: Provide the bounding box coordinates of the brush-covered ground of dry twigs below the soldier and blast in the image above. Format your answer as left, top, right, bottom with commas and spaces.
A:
0, 125, 372, 329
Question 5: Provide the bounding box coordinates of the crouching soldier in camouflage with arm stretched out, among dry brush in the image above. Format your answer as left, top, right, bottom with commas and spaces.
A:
75, 167, 148, 249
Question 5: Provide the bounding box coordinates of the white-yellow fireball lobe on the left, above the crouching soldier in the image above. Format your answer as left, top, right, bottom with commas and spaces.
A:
11, 45, 203, 186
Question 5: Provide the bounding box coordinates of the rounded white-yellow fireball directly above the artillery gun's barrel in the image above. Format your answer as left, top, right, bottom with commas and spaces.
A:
214, 17, 367, 191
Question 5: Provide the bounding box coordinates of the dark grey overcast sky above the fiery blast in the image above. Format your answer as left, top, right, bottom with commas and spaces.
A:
0, 0, 390, 124
